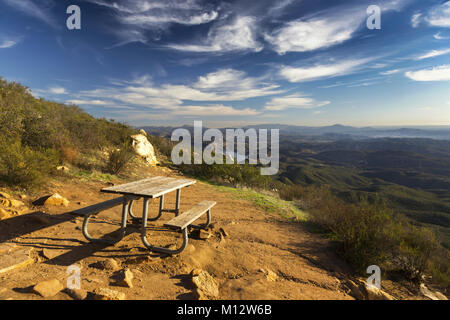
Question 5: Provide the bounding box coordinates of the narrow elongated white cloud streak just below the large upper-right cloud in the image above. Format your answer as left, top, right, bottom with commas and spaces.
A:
280, 59, 369, 82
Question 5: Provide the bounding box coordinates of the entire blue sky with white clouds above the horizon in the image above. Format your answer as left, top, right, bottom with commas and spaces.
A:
0, 0, 450, 127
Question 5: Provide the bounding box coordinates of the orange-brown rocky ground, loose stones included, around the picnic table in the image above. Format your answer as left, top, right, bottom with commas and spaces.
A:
0, 167, 444, 300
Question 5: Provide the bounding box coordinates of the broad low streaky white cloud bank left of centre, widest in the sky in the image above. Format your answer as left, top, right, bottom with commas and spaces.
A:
70, 69, 284, 116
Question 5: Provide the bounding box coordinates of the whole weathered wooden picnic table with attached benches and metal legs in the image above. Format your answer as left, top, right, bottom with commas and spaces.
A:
74, 177, 216, 254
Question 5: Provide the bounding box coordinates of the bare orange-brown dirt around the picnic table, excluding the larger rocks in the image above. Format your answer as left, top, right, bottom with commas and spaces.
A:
0, 169, 353, 300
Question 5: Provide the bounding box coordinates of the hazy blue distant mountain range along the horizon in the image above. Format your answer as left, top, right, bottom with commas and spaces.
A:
142, 124, 450, 140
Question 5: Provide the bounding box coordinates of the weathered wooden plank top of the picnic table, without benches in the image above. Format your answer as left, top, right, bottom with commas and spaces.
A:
101, 177, 196, 198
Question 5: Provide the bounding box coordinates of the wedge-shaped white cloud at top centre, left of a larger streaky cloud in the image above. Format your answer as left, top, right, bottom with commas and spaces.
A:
168, 17, 263, 52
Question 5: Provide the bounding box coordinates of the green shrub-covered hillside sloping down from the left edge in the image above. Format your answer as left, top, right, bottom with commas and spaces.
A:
0, 78, 136, 188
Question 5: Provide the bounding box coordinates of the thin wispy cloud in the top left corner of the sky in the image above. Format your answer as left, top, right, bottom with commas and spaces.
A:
2, 0, 57, 28
